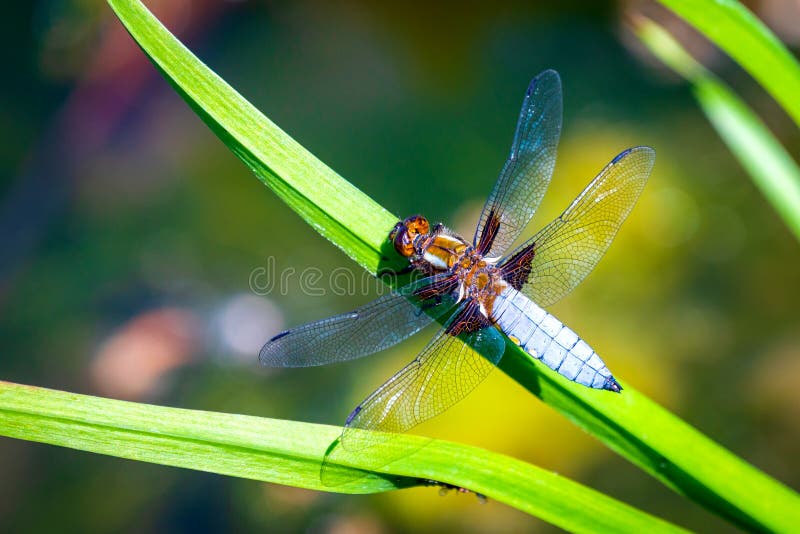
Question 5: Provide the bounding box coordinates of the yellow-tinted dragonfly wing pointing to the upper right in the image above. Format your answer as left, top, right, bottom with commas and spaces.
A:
501, 147, 656, 306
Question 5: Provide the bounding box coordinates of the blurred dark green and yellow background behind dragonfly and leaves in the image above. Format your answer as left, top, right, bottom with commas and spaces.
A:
0, 0, 800, 533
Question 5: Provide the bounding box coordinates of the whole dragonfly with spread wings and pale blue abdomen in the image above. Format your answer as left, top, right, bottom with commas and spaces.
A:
259, 70, 655, 456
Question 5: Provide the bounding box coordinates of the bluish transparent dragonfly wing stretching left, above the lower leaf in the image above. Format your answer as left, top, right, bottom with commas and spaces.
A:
258, 273, 455, 367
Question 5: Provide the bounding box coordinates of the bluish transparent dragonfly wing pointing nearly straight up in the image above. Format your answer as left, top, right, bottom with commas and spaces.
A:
473, 70, 562, 256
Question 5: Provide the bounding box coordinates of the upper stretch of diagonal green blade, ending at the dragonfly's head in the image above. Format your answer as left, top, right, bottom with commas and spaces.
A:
109, 0, 397, 272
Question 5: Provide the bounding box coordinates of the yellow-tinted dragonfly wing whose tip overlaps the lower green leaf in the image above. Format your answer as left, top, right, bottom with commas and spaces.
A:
341, 301, 505, 452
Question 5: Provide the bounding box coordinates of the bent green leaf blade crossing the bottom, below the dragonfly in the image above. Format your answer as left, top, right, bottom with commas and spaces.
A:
0, 382, 681, 532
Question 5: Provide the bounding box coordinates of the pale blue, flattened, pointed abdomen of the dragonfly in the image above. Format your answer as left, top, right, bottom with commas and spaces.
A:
494, 288, 622, 391
